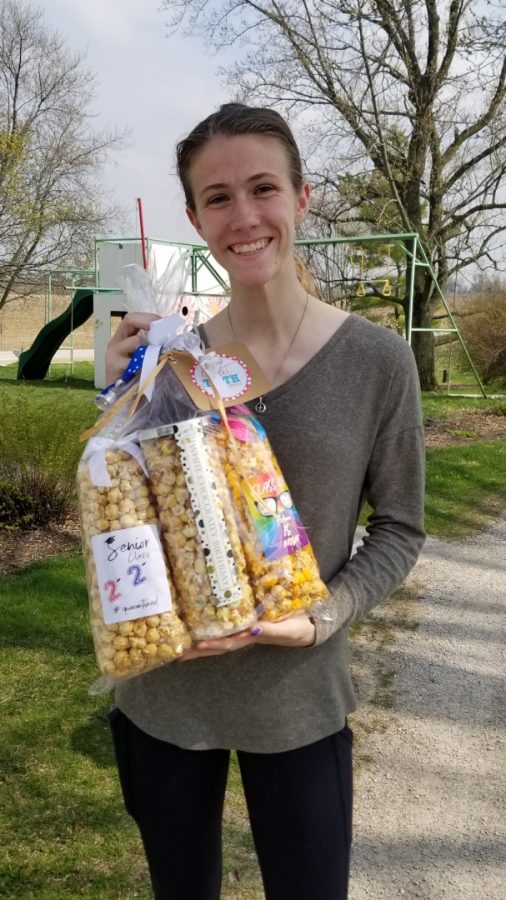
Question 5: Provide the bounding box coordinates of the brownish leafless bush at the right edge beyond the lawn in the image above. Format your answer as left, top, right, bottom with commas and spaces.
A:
460, 286, 506, 382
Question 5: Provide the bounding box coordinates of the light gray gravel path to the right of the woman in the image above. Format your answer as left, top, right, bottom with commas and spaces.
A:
350, 517, 506, 900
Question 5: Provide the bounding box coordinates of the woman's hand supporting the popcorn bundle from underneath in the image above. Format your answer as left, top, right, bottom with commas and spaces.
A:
178, 616, 316, 662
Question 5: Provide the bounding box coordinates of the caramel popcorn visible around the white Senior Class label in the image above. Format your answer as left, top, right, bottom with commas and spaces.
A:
78, 450, 191, 683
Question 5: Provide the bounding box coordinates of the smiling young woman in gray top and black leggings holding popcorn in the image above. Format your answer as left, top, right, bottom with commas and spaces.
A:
108, 104, 424, 900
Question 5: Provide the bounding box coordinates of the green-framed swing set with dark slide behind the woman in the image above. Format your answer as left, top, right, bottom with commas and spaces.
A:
18, 233, 487, 397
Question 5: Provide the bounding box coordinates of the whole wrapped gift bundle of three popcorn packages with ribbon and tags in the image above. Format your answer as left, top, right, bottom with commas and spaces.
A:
78, 266, 327, 684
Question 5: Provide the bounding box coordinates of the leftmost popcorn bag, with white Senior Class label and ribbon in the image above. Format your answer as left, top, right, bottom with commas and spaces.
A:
77, 438, 191, 692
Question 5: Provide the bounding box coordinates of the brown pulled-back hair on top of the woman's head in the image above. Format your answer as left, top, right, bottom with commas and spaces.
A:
176, 103, 304, 212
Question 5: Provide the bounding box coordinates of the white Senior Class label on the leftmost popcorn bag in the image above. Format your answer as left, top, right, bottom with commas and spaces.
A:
91, 525, 172, 625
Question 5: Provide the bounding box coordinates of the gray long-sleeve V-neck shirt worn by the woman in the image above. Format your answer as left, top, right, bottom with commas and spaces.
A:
116, 316, 424, 753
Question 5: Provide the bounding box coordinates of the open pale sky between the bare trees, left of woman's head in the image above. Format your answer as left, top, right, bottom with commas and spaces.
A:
41, 0, 233, 242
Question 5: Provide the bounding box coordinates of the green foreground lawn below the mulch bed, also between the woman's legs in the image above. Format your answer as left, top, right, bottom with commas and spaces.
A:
0, 555, 262, 900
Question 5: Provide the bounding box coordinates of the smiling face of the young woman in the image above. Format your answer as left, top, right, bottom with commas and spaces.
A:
187, 134, 310, 287
